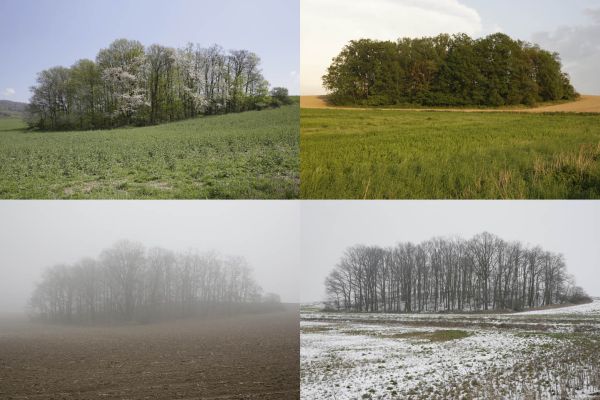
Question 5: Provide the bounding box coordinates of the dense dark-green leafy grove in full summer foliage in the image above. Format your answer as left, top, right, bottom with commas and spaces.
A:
323, 33, 578, 106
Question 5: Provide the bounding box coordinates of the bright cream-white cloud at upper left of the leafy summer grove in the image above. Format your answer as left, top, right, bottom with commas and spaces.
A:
300, 0, 482, 94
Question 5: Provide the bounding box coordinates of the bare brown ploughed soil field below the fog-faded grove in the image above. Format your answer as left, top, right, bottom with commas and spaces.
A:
0, 307, 300, 400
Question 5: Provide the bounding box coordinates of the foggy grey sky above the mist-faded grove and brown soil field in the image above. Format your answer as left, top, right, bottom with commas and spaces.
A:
0, 200, 300, 312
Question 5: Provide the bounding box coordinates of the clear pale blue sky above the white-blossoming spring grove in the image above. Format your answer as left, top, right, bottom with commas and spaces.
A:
0, 0, 300, 101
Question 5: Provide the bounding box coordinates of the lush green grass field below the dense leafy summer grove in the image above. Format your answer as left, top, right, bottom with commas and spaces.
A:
300, 109, 600, 199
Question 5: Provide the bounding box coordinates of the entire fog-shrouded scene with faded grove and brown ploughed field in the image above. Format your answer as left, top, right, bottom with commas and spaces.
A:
0, 201, 299, 399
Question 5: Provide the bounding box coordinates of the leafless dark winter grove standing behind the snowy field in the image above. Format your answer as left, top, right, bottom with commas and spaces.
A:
325, 232, 590, 313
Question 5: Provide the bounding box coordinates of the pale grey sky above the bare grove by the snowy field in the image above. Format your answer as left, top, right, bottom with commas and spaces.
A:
300, 201, 600, 302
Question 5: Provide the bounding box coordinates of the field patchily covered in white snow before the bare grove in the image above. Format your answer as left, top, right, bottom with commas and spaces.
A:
300, 301, 600, 400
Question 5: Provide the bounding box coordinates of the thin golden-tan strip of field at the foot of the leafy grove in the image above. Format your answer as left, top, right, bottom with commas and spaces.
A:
300, 95, 600, 113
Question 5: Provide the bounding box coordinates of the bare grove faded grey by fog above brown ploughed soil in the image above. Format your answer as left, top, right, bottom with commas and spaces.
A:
30, 241, 270, 323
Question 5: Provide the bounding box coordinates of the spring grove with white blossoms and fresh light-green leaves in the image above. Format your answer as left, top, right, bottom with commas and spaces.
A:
27, 39, 287, 130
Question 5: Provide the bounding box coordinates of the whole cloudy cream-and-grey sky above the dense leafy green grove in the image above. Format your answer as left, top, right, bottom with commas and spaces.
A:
300, 0, 600, 95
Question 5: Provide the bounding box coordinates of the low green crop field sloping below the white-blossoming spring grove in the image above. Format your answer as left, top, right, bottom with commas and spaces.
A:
0, 105, 299, 199
